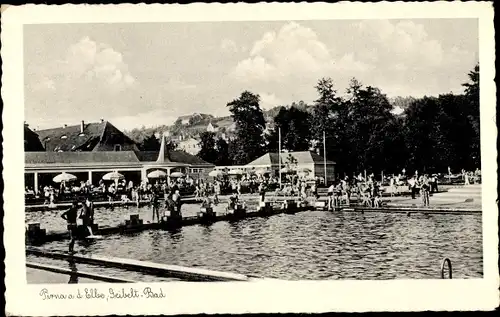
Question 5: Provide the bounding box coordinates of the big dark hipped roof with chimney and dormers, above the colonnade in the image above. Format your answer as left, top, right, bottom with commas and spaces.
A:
37, 121, 135, 152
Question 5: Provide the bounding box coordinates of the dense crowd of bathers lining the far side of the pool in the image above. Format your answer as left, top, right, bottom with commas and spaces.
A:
25, 165, 481, 212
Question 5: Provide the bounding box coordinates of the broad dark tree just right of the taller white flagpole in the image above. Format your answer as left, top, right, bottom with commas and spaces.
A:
342, 79, 404, 174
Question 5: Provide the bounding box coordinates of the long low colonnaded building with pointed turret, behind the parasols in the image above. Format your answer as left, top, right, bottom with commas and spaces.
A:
25, 126, 214, 191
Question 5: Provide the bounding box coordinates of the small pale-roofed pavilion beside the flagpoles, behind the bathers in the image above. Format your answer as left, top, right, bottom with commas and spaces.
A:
216, 151, 335, 184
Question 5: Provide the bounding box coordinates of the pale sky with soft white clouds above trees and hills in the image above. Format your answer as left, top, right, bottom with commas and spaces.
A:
23, 19, 479, 130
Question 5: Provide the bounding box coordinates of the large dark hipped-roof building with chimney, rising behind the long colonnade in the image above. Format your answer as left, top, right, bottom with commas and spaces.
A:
37, 120, 139, 152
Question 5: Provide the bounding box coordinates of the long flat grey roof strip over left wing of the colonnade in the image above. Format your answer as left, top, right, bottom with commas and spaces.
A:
24, 151, 140, 164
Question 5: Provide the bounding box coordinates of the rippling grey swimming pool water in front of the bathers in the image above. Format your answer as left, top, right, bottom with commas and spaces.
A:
27, 205, 483, 280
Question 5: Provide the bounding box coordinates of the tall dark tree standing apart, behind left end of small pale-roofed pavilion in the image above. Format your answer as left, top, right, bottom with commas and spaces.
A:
227, 91, 266, 164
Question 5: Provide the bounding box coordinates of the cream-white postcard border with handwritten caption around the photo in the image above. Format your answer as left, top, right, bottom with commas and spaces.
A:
1, 2, 499, 316
